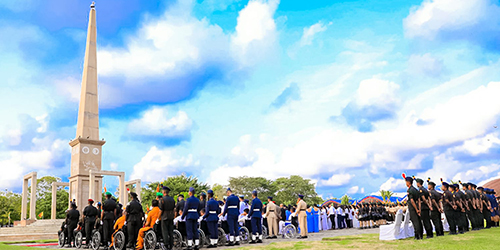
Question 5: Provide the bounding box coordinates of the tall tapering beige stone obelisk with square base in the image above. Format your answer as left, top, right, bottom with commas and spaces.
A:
69, 3, 106, 209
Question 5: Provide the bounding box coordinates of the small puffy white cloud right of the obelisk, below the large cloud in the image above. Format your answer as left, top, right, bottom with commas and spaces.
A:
128, 107, 193, 138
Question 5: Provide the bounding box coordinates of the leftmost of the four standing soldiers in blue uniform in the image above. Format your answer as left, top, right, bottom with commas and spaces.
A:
181, 187, 200, 250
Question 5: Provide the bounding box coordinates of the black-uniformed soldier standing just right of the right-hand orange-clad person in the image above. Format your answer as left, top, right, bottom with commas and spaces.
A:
160, 187, 175, 250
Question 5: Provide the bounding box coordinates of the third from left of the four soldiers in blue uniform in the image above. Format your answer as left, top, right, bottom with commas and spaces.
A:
222, 188, 240, 246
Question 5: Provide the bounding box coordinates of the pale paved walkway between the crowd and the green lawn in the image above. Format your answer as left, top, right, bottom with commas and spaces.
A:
19, 228, 379, 249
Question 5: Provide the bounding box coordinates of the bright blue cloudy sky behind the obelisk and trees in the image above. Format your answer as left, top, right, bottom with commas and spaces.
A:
0, 0, 500, 198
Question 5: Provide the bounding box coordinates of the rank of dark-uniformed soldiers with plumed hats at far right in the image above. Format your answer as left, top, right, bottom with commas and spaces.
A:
403, 174, 499, 240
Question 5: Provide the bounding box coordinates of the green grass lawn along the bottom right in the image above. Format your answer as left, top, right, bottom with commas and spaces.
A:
240, 228, 500, 250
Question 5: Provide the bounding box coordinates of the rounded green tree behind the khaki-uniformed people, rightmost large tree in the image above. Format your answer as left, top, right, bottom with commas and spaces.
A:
272, 175, 323, 205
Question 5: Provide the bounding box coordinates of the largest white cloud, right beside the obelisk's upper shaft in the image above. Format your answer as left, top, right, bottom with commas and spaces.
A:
95, 0, 279, 107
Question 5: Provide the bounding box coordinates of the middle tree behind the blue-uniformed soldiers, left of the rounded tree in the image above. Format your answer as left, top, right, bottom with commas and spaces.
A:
228, 176, 276, 200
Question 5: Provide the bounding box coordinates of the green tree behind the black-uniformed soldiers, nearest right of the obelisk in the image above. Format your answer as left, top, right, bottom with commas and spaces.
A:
141, 174, 210, 211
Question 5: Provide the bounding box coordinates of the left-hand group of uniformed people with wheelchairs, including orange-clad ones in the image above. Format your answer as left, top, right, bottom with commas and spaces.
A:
59, 185, 316, 249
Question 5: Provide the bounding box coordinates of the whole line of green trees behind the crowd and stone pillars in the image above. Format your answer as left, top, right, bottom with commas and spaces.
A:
0, 174, 323, 225
